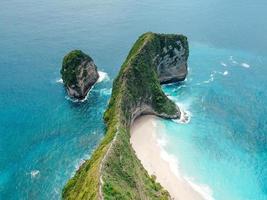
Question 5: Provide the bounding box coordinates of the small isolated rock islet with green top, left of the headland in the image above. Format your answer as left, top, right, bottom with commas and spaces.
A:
60, 50, 99, 100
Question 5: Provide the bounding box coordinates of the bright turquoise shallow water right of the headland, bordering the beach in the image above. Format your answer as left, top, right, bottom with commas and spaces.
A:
159, 44, 267, 200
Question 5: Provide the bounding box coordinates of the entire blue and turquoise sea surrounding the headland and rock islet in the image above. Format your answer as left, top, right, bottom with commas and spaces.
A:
0, 0, 267, 200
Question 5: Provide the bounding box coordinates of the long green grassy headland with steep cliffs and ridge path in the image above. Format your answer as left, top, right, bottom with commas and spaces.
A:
63, 33, 189, 200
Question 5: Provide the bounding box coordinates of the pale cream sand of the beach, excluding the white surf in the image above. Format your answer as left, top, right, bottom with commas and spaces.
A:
131, 116, 203, 200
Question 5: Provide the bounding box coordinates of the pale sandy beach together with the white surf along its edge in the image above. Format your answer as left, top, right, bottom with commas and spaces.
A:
130, 116, 213, 200
